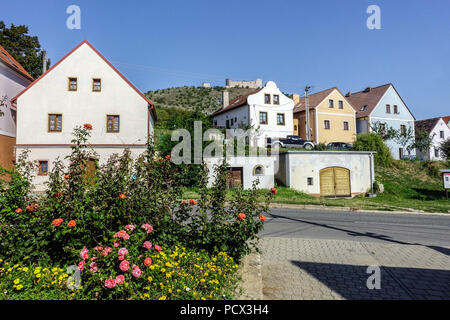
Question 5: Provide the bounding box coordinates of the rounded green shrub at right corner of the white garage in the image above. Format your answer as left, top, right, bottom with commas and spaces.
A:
353, 132, 393, 168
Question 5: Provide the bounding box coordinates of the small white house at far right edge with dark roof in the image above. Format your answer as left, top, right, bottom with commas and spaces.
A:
414, 117, 450, 160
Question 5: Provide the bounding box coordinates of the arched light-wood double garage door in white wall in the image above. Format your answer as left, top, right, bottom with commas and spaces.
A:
320, 167, 351, 197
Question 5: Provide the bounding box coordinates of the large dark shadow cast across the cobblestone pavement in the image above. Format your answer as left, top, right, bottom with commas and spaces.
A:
291, 261, 450, 300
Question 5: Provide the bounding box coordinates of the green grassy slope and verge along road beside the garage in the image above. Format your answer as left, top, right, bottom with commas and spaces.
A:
184, 161, 450, 213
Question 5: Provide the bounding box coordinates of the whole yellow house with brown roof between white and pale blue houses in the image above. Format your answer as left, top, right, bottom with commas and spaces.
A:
293, 87, 356, 144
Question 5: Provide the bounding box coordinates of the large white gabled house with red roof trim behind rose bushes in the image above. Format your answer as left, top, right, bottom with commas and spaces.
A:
12, 41, 156, 189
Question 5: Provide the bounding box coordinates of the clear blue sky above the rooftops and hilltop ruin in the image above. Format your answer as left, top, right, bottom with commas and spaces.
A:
0, 0, 450, 119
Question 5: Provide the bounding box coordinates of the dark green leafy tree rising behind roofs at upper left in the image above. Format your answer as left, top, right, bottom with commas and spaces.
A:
0, 21, 50, 79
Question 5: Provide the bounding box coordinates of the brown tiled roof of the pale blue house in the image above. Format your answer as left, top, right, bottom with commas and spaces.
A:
345, 83, 391, 118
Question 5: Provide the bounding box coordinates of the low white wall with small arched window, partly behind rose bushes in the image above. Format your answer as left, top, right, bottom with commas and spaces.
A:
203, 156, 276, 189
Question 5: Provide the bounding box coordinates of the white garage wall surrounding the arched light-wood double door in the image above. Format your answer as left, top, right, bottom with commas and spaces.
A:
276, 151, 375, 195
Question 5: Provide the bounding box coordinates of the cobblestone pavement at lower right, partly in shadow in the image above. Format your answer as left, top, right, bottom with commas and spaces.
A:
260, 237, 450, 300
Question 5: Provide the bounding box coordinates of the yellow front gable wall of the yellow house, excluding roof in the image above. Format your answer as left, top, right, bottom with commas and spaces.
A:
316, 90, 356, 144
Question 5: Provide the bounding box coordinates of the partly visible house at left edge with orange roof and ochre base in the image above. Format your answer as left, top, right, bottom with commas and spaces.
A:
0, 46, 33, 169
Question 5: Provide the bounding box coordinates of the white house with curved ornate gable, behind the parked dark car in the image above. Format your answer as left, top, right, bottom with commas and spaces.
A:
213, 81, 294, 147
